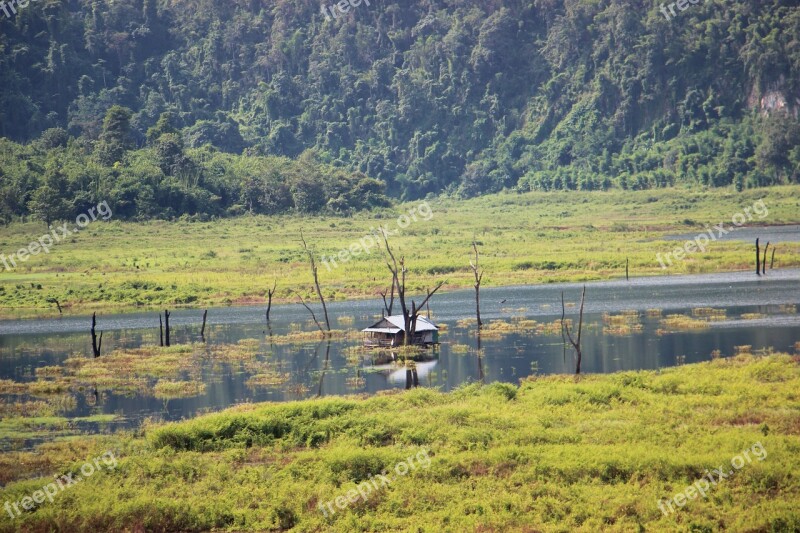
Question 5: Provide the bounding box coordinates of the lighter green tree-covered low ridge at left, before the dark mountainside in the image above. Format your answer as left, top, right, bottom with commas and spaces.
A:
0, 107, 389, 223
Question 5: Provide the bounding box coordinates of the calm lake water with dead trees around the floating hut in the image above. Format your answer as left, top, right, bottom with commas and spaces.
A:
0, 269, 800, 448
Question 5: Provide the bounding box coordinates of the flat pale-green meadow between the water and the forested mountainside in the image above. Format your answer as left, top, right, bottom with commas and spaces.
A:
0, 186, 800, 317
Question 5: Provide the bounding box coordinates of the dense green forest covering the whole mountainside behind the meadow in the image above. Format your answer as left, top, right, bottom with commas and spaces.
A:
0, 0, 800, 221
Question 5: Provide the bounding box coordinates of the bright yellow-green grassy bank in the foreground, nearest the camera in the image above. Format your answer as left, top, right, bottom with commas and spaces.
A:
0, 354, 800, 532
